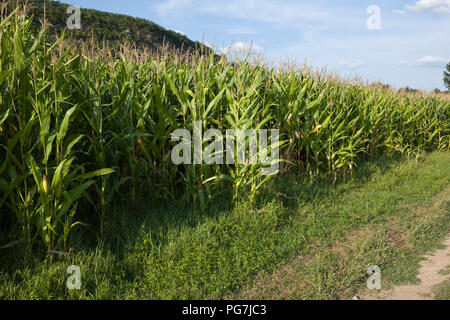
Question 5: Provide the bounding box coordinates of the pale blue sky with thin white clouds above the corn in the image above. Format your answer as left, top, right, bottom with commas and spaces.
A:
67, 0, 450, 90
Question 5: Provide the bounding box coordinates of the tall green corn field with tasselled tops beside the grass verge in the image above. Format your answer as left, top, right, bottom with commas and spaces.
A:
0, 12, 450, 249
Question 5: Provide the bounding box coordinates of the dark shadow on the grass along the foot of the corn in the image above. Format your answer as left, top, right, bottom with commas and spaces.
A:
96, 152, 404, 257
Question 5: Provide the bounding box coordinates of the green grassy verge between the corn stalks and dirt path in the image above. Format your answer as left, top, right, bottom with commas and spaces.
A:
0, 152, 450, 299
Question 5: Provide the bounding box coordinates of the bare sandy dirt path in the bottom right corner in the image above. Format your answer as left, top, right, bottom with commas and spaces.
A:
361, 237, 450, 300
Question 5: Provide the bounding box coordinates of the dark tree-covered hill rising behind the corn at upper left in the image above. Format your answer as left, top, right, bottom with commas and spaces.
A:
11, 0, 211, 51
